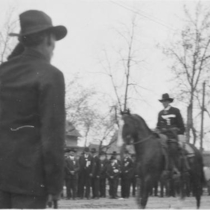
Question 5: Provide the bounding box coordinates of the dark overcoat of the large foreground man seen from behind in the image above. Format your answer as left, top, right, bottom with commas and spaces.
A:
0, 49, 65, 195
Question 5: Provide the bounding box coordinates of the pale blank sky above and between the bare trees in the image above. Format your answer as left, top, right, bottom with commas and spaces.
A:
0, 0, 210, 148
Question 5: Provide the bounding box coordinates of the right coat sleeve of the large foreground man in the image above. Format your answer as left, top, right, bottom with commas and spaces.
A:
39, 69, 65, 194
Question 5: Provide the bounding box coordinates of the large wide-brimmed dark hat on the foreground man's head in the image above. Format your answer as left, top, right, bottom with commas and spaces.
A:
9, 10, 67, 41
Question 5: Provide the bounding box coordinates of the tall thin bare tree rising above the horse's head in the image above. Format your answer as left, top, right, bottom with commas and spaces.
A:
100, 15, 143, 115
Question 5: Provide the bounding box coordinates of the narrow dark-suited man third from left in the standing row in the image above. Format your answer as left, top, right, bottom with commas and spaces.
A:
91, 148, 101, 199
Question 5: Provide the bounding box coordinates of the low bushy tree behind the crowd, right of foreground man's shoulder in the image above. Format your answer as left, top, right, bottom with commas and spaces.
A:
66, 77, 114, 149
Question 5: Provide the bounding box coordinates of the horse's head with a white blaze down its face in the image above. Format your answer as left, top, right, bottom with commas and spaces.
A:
117, 111, 145, 147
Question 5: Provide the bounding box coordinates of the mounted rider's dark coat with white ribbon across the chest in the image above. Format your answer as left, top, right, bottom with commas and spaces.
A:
157, 106, 185, 134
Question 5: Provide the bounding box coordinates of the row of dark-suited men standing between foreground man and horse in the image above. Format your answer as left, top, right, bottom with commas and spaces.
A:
63, 148, 138, 199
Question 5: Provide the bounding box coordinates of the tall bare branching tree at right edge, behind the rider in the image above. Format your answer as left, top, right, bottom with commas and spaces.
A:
164, 2, 210, 144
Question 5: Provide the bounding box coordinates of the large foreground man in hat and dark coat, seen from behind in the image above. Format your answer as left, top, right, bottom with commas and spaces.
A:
0, 10, 67, 209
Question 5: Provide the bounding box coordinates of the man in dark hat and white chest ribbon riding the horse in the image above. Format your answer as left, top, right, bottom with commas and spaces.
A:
157, 93, 189, 176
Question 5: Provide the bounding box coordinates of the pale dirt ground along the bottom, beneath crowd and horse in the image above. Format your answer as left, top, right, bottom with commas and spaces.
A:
58, 195, 210, 209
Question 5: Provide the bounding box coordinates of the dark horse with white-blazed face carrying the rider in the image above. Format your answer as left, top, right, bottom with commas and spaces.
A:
117, 112, 203, 208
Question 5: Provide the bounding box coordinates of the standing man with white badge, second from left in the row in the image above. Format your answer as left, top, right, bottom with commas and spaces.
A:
78, 147, 93, 199
